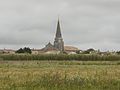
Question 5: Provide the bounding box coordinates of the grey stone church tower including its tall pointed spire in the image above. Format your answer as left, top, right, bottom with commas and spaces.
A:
54, 19, 64, 51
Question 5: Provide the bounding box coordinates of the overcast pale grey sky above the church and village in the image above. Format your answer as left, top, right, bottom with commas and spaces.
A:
0, 0, 120, 50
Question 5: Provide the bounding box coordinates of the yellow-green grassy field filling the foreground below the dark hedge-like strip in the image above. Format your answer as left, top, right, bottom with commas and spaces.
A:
0, 61, 120, 90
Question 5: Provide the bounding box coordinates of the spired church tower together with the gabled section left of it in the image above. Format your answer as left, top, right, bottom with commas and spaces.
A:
39, 20, 64, 54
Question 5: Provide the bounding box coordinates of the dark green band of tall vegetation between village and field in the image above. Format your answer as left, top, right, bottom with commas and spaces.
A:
0, 54, 120, 61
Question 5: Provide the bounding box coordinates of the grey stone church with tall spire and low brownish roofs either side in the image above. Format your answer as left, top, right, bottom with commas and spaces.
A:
32, 19, 79, 54
